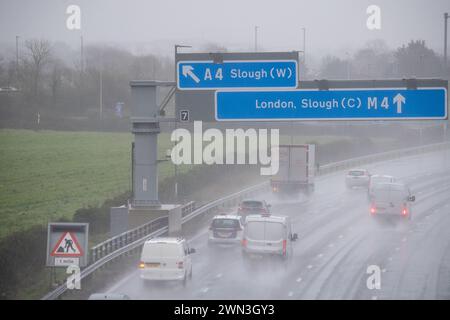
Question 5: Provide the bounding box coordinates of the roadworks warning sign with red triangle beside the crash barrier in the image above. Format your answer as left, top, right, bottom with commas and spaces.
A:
47, 223, 89, 267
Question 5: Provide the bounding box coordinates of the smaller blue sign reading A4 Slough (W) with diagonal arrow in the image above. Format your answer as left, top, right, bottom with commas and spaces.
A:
177, 60, 297, 90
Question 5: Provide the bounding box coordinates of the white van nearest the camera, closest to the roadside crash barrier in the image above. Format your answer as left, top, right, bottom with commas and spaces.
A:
139, 238, 195, 284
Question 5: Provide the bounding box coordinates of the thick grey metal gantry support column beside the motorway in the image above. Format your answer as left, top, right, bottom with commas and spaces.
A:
130, 81, 173, 208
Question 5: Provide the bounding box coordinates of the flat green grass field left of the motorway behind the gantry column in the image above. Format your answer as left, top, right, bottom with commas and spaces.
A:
0, 130, 183, 238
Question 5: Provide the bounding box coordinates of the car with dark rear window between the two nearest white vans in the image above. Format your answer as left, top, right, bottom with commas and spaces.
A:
208, 215, 244, 244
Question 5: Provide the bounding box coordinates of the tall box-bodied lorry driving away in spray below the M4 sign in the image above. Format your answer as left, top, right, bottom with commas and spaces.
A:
270, 144, 316, 194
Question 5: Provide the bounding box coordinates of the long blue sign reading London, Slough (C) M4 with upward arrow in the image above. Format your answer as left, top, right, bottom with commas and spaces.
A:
215, 88, 447, 121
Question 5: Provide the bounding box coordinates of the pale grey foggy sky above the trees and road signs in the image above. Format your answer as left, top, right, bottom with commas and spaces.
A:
0, 0, 450, 57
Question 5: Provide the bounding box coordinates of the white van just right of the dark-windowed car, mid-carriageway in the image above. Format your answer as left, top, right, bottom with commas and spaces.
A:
242, 214, 298, 261
